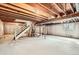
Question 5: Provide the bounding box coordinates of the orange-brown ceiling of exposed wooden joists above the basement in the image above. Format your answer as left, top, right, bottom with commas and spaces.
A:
0, 3, 75, 22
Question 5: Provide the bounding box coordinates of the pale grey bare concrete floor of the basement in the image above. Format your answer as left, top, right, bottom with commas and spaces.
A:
0, 35, 79, 55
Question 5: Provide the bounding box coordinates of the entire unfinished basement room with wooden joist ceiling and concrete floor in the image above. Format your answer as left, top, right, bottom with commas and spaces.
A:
0, 3, 79, 55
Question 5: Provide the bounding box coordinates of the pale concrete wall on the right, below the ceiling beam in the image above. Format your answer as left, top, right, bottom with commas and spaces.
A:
36, 22, 79, 38
